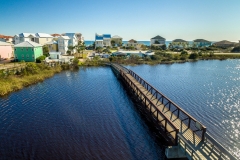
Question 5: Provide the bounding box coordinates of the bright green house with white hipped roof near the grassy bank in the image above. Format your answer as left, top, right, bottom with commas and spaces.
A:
14, 41, 43, 62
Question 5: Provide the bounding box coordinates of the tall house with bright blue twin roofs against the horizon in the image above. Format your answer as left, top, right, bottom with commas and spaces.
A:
95, 33, 111, 48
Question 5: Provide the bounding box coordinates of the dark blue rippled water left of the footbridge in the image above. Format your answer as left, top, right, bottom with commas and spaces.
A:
0, 67, 164, 160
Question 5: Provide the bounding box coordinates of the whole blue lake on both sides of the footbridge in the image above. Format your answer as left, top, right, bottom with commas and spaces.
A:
0, 60, 240, 160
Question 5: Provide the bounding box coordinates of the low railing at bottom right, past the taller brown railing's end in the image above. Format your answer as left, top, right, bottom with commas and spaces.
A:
204, 133, 237, 160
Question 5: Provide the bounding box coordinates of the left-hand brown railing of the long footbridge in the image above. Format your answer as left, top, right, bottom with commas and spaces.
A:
120, 69, 179, 145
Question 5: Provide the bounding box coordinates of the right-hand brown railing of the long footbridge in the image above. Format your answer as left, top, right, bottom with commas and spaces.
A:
128, 70, 206, 141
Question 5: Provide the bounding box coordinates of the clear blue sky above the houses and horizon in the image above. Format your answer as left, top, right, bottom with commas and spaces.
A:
0, 0, 240, 41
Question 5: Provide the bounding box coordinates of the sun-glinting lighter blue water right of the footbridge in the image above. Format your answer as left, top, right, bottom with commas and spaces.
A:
128, 60, 240, 157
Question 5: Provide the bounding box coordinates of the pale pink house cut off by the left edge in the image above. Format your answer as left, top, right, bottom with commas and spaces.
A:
0, 41, 13, 60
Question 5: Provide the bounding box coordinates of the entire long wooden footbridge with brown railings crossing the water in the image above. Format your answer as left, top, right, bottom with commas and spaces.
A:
111, 63, 237, 160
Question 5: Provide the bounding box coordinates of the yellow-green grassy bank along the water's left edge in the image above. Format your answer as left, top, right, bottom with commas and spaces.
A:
0, 63, 62, 96
